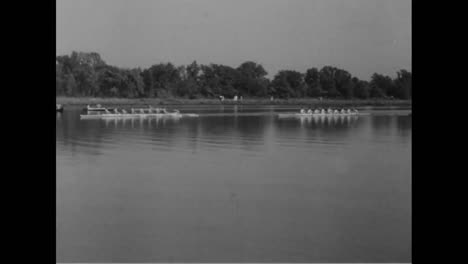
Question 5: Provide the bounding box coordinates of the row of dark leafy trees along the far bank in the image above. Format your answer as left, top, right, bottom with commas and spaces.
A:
56, 52, 412, 99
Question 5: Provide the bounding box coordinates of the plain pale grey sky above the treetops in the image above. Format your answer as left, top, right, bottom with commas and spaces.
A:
57, 0, 411, 80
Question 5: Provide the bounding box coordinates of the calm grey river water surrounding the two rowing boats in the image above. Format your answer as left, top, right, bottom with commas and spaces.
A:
56, 106, 412, 262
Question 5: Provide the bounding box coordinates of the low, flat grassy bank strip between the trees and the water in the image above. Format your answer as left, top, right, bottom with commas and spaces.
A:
56, 97, 411, 106
